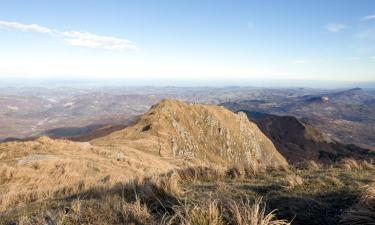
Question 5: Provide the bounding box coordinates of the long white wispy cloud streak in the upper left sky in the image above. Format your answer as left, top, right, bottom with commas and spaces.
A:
0, 21, 137, 51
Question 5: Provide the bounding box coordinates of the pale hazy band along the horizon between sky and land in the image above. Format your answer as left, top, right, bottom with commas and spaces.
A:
0, 78, 375, 89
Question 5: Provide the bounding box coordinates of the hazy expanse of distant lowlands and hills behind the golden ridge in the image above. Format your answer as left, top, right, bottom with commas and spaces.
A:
0, 86, 375, 151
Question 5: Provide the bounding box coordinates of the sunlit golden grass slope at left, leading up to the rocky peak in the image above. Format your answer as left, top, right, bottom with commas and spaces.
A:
0, 137, 179, 212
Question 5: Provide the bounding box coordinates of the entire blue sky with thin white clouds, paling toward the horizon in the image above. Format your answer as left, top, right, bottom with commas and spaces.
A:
0, 0, 375, 83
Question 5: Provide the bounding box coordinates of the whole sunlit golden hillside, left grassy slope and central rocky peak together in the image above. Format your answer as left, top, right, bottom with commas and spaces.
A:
0, 100, 287, 211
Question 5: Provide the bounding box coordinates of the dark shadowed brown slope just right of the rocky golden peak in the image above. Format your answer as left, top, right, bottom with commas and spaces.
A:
245, 111, 375, 163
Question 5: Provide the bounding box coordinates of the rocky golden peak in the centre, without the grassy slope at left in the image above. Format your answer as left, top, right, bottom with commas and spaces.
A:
91, 100, 286, 167
